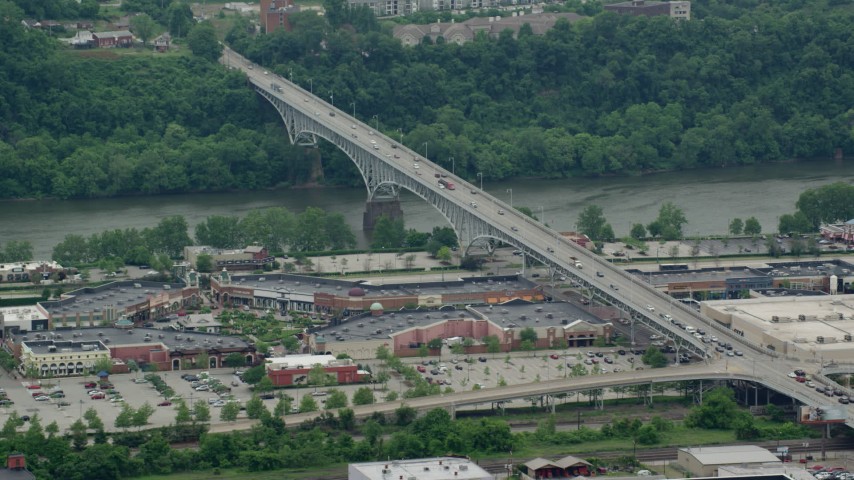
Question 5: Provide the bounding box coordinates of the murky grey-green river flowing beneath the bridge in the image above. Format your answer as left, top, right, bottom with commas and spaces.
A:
0, 161, 854, 259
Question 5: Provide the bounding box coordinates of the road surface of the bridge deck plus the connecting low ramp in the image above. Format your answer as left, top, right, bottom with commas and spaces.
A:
221, 48, 854, 424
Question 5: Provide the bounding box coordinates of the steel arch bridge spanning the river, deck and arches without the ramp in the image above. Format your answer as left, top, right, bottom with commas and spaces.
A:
226, 48, 744, 357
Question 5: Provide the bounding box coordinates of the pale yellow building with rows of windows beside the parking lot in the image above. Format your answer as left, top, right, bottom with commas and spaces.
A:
19, 340, 110, 377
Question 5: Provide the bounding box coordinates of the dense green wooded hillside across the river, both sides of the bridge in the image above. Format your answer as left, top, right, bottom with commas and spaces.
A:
0, 0, 854, 198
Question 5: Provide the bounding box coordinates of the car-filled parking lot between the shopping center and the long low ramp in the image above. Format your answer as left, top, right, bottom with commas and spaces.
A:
0, 336, 704, 430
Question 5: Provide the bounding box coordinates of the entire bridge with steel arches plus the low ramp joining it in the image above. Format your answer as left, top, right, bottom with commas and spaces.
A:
220, 47, 854, 425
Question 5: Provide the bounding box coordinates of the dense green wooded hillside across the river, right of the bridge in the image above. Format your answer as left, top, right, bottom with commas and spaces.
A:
229, 0, 854, 182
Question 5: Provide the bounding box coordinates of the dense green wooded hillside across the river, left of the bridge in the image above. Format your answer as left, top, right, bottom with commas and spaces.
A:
0, 0, 311, 198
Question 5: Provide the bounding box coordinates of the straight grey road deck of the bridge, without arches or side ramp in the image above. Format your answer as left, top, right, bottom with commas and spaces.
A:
221, 48, 708, 353
